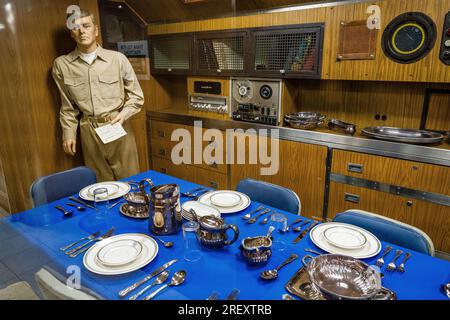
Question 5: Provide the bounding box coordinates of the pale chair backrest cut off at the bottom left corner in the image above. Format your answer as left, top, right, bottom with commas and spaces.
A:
34, 267, 103, 300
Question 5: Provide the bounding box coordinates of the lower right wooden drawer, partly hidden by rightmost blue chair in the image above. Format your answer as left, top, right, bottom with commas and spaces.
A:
328, 182, 450, 252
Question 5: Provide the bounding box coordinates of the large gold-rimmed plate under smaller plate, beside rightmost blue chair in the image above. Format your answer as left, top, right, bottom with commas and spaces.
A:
310, 222, 382, 259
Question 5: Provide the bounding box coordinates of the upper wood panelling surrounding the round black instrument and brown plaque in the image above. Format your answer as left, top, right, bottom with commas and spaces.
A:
148, 0, 450, 83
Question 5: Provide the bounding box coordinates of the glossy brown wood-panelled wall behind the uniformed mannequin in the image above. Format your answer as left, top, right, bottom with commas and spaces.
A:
0, 0, 148, 213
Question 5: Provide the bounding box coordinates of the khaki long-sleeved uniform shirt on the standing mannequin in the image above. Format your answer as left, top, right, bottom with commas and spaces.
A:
52, 46, 144, 140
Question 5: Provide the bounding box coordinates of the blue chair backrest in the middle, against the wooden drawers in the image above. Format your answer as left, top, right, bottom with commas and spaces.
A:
236, 179, 302, 215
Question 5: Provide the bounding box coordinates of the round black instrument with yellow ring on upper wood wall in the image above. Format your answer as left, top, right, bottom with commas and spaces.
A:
381, 12, 436, 63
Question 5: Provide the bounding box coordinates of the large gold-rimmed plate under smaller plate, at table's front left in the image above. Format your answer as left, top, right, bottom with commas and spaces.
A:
83, 233, 158, 275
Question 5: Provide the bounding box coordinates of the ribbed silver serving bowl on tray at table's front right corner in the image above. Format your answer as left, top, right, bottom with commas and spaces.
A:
302, 254, 382, 300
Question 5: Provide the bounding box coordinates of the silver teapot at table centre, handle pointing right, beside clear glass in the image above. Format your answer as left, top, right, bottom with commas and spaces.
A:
190, 209, 239, 249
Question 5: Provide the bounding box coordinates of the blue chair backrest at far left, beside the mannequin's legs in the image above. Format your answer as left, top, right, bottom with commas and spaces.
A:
30, 167, 97, 207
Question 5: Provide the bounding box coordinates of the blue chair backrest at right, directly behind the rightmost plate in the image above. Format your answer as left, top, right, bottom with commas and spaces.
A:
333, 210, 434, 256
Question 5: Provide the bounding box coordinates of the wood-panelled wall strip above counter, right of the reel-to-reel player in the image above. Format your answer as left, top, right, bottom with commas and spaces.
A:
298, 80, 427, 129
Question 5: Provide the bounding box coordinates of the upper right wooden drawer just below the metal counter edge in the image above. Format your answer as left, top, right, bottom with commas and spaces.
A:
332, 150, 450, 195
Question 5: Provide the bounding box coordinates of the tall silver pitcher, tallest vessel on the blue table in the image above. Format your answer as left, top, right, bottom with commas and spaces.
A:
139, 179, 182, 235
